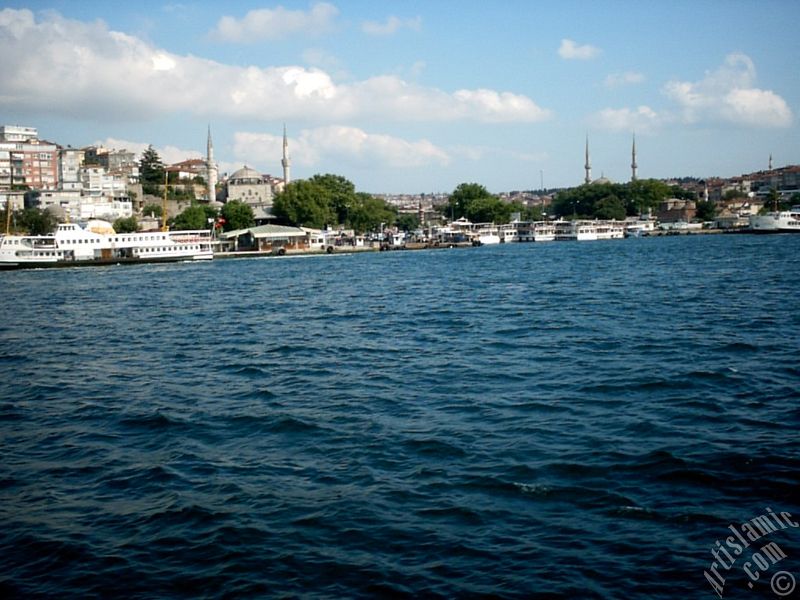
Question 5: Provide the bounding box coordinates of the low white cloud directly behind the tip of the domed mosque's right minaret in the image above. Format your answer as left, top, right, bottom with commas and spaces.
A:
234, 125, 450, 169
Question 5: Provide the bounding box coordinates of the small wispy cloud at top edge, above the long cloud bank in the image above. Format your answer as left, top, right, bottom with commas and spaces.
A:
211, 2, 339, 43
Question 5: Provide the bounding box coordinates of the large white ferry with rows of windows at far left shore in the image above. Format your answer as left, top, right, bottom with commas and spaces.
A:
0, 219, 214, 269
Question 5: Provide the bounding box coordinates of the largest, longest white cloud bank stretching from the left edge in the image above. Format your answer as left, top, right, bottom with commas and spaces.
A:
0, 9, 550, 123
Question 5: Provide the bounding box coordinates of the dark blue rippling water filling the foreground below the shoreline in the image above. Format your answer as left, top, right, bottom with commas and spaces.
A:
0, 236, 800, 598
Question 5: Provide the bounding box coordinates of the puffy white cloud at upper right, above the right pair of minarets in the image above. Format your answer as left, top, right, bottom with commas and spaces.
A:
664, 52, 793, 127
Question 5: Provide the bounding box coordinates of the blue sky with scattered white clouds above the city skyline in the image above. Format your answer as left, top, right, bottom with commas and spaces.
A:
0, 0, 800, 193
